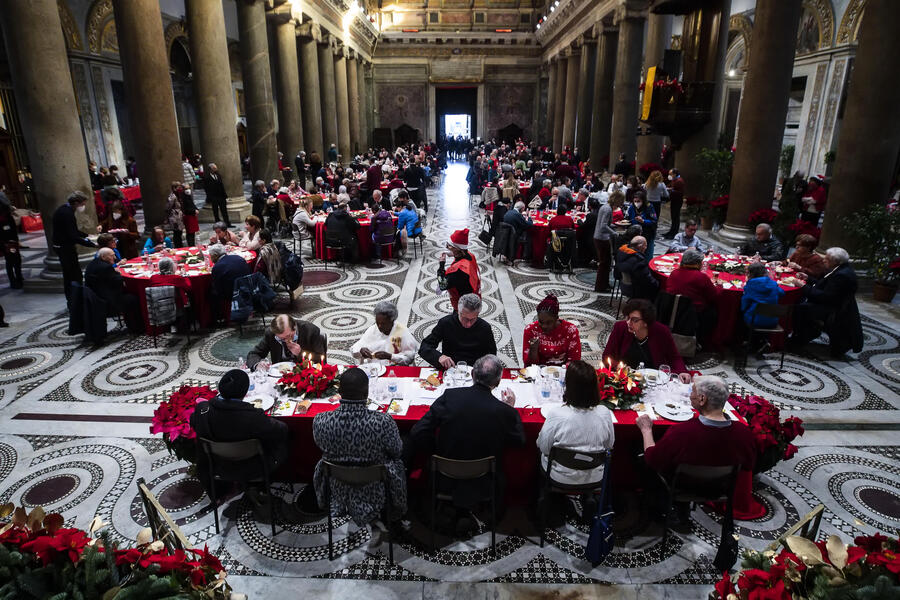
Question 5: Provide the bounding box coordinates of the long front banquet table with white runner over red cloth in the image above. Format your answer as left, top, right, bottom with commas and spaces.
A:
256, 366, 765, 519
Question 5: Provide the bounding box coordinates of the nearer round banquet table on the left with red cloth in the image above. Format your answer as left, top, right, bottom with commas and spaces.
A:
120, 246, 256, 334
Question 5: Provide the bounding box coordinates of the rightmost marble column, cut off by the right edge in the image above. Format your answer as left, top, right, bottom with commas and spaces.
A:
820, 0, 900, 253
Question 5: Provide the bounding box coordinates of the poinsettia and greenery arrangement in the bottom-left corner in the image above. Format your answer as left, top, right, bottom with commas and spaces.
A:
0, 504, 236, 600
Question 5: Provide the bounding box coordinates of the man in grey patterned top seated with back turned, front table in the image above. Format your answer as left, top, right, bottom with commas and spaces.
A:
312, 369, 406, 547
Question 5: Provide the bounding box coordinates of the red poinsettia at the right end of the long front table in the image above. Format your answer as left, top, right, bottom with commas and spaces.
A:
728, 394, 803, 473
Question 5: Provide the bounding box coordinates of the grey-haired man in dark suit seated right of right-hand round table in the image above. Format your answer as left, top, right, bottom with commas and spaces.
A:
790, 248, 863, 358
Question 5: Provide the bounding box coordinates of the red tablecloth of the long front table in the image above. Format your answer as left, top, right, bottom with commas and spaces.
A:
276, 367, 765, 519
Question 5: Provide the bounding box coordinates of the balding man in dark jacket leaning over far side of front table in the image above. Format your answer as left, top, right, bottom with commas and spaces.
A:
247, 315, 328, 371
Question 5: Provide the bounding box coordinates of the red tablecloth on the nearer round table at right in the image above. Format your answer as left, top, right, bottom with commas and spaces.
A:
650, 252, 803, 349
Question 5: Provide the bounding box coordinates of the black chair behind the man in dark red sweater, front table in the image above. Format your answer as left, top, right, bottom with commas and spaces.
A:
660, 464, 741, 547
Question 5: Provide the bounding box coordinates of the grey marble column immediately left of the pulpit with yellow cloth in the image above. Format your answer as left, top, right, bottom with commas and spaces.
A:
609, 6, 646, 170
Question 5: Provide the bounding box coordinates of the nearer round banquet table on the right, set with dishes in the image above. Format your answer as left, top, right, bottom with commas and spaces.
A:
650, 252, 803, 349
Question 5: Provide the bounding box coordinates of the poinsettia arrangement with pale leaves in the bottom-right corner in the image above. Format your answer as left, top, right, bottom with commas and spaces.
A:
715, 534, 900, 600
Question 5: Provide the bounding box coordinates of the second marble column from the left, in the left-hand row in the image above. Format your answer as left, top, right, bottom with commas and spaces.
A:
113, 0, 181, 231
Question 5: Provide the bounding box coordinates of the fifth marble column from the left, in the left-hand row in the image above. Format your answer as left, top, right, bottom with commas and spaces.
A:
275, 15, 304, 165
